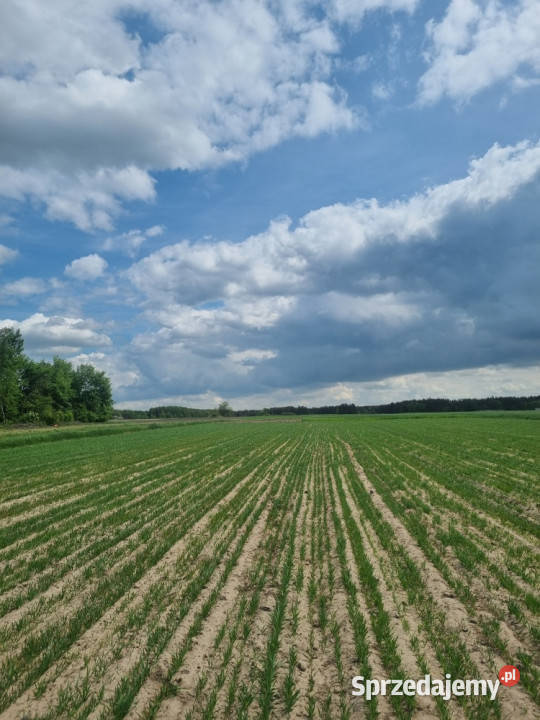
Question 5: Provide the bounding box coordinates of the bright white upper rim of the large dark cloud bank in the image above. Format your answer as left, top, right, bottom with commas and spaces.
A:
127, 142, 540, 312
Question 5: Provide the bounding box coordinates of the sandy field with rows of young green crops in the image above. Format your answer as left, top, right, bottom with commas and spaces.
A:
0, 413, 540, 720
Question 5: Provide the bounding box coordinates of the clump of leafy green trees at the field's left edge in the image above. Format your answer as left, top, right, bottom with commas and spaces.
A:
0, 327, 113, 425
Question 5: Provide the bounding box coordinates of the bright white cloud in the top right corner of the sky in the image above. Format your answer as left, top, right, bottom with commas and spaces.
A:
419, 0, 540, 104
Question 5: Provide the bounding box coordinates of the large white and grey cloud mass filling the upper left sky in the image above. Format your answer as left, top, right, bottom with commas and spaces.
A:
0, 0, 376, 230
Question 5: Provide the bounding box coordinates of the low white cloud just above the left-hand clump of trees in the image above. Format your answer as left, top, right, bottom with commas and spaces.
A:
0, 313, 111, 354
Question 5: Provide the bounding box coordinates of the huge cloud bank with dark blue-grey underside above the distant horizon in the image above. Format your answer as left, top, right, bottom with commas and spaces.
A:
116, 136, 540, 400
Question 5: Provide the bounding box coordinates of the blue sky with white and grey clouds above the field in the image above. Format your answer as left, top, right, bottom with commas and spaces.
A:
0, 0, 540, 409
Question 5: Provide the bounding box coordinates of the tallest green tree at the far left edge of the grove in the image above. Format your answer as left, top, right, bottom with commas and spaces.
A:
0, 327, 24, 423
